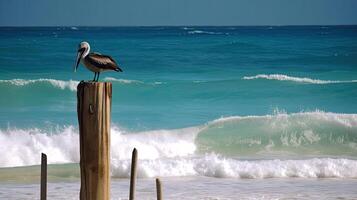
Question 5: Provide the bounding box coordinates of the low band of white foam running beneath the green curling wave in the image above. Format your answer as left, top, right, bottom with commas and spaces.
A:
112, 154, 357, 179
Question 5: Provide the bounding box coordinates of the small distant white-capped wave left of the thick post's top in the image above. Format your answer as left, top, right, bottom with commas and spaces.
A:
0, 78, 79, 91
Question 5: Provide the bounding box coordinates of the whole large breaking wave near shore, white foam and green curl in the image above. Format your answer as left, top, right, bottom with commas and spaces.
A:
0, 111, 357, 178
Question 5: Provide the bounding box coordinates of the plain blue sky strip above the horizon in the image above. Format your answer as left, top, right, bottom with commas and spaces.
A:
0, 0, 357, 26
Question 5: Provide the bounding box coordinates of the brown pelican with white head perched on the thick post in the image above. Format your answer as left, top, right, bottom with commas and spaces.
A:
74, 42, 123, 81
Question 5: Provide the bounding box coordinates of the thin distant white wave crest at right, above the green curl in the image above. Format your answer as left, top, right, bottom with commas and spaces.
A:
243, 74, 357, 84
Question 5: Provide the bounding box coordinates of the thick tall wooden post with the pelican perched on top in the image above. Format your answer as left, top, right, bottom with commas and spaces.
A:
77, 81, 112, 200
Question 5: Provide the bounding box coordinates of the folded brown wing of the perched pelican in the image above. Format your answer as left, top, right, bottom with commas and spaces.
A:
87, 53, 118, 70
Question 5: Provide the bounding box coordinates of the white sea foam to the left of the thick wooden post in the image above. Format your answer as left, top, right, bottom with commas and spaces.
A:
0, 127, 79, 167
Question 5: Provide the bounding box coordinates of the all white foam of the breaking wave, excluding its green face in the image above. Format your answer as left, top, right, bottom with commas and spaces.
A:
0, 111, 357, 178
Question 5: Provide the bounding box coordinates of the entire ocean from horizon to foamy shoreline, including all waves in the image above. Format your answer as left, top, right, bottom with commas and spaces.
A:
0, 26, 357, 199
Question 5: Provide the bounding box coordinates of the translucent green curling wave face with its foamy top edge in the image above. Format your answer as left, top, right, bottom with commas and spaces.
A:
196, 111, 357, 157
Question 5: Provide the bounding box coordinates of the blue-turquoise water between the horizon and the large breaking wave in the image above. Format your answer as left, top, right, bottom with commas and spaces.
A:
0, 26, 357, 130
